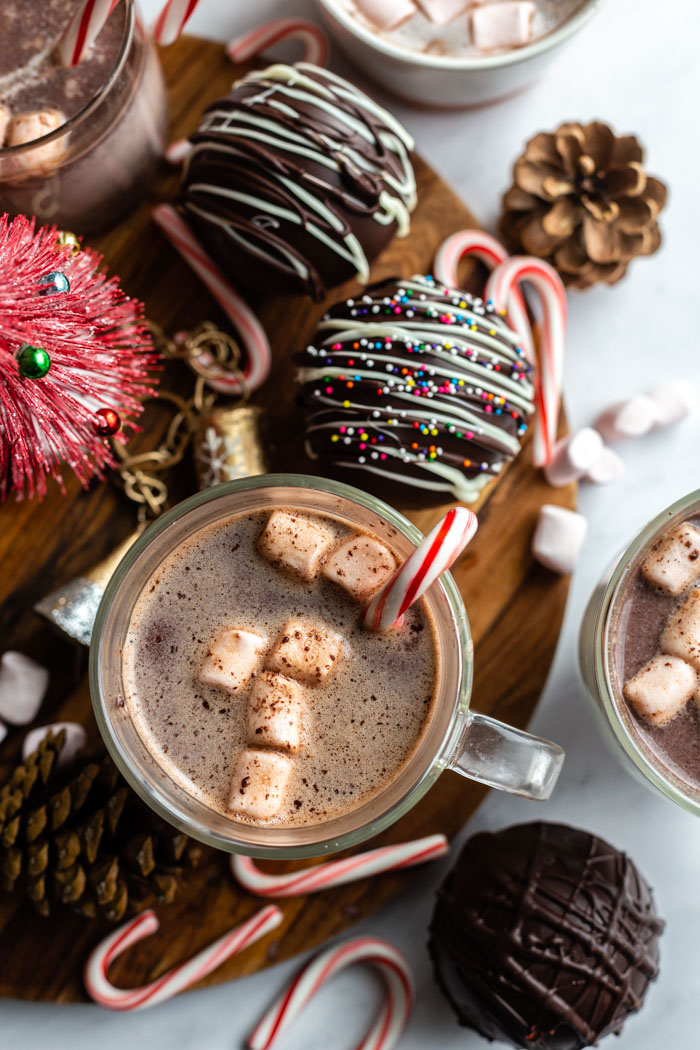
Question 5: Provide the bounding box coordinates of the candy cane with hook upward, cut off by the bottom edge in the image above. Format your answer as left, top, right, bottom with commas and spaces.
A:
248, 937, 413, 1050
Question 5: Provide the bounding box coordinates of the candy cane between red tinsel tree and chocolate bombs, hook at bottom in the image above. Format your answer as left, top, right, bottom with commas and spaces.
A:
153, 204, 270, 394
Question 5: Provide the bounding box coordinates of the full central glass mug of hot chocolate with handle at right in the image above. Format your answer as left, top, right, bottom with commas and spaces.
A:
90, 475, 564, 857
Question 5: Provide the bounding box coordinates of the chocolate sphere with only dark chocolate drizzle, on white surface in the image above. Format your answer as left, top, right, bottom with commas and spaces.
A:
429, 823, 663, 1050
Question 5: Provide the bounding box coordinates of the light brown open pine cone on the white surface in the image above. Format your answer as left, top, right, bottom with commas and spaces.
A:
501, 121, 666, 288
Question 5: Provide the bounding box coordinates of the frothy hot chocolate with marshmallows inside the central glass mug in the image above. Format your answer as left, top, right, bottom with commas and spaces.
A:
124, 507, 439, 826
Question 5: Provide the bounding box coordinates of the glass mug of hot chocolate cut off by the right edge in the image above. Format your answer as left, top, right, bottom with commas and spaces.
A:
579, 490, 700, 815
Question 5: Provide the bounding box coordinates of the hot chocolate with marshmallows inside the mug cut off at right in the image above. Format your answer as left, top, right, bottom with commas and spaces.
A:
611, 515, 700, 791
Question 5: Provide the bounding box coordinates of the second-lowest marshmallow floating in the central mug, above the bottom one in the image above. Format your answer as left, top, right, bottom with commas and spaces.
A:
248, 671, 303, 751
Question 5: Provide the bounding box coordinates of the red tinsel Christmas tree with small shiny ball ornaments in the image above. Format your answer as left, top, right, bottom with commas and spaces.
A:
0, 215, 157, 500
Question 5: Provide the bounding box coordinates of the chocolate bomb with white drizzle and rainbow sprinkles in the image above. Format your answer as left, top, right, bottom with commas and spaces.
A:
296, 276, 534, 505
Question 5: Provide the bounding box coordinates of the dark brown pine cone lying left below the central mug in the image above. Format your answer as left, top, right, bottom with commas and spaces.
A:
0, 732, 200, 922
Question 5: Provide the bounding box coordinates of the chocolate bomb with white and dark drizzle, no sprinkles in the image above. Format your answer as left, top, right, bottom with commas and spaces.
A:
181, 62, 416, 299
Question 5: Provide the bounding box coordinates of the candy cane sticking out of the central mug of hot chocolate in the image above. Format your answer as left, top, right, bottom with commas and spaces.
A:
362, 507, 479, 631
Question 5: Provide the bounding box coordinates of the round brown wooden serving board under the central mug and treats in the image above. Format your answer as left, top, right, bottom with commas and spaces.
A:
0, 38, 575, 1002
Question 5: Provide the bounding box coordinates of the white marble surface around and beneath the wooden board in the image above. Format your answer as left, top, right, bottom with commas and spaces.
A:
5, 0, 700, 1050
